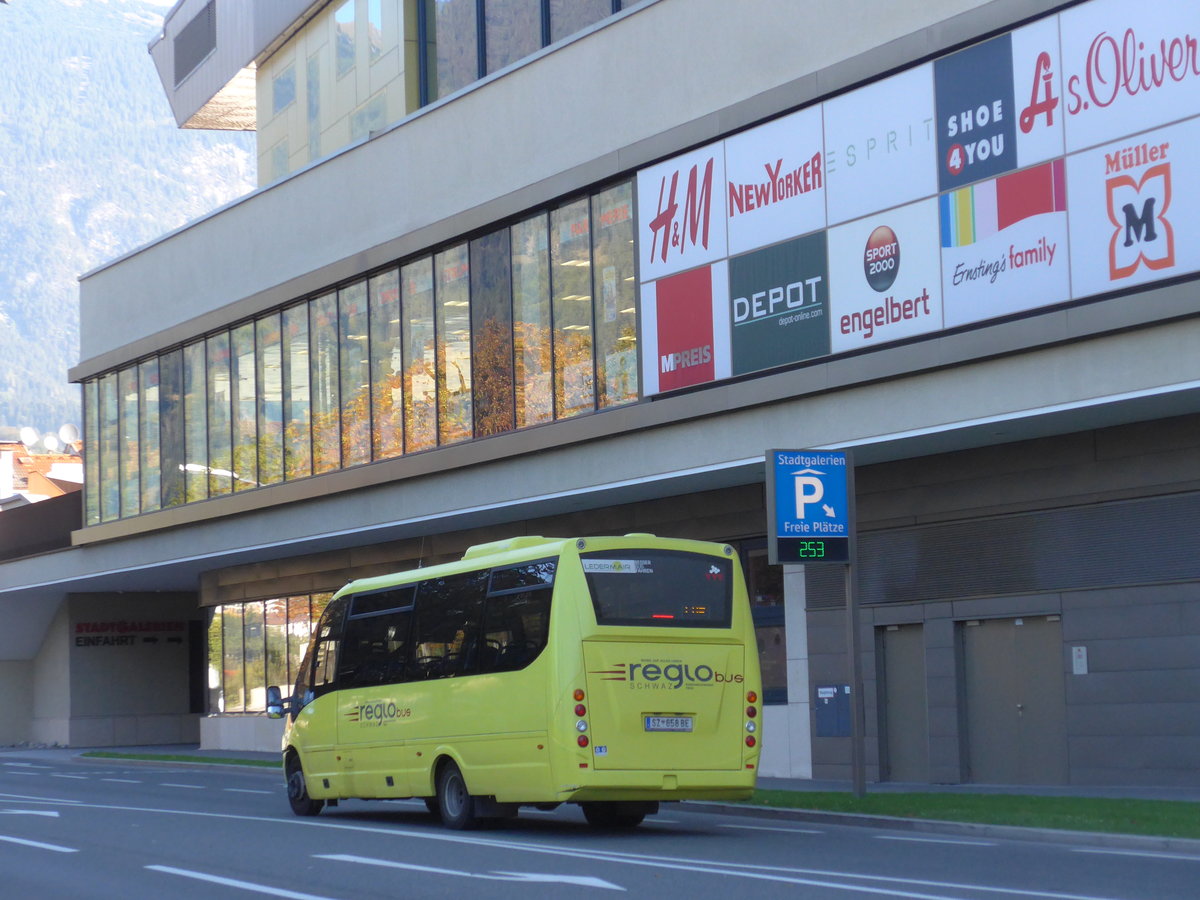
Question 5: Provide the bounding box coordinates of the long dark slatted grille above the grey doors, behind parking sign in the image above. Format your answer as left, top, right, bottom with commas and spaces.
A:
805, 493, 1200, 608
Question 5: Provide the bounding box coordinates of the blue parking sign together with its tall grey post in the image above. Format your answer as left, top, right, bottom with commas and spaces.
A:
767, 450, 866, 797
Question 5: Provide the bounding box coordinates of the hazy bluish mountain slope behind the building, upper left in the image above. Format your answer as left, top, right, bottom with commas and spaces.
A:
0, 0, 254, 437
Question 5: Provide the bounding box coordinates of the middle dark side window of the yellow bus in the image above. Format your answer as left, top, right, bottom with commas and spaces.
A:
406, 570, 488, 680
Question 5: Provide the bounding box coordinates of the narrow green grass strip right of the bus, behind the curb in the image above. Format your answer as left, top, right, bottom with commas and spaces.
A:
748, 791, 1200, 839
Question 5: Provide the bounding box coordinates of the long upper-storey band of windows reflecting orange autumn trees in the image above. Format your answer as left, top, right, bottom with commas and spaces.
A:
84, 181, 638, 525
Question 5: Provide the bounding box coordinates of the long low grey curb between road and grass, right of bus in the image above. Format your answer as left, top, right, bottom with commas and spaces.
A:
677, 800, 1200, 859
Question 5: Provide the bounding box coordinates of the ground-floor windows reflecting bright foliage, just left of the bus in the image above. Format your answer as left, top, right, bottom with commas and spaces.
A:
208, 594, 332, 713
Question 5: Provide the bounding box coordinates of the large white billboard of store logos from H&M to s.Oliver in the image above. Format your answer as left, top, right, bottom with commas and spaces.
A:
637, 0, 1200, 396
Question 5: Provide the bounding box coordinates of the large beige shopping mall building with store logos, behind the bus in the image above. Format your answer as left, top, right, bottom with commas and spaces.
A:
0, 0, 1200, 785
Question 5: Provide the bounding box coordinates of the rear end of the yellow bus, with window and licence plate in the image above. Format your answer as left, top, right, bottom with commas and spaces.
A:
580, 548, 752, 769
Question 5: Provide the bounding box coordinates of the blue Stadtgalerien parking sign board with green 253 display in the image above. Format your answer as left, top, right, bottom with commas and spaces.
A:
767, 450, 854, 564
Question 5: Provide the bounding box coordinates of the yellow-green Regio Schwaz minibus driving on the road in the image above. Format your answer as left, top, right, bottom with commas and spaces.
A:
268, 534, 762, 828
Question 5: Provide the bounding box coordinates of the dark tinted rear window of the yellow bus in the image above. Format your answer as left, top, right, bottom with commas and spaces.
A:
581, 550, 733, 628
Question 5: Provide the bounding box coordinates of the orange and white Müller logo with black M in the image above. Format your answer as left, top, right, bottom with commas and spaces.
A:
1104, 142, 1175, 281
